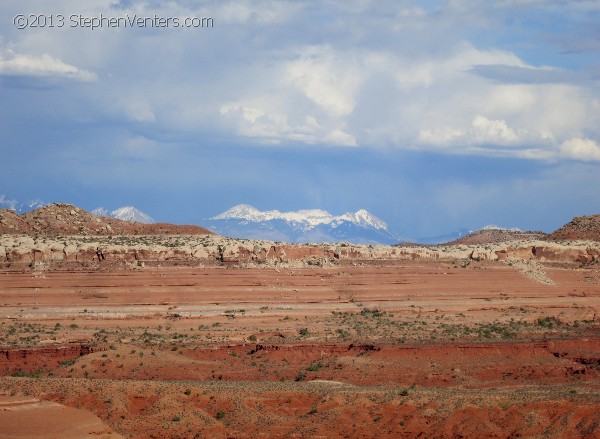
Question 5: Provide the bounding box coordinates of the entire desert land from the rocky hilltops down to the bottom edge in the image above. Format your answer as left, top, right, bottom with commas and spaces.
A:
0, 204, 600, 438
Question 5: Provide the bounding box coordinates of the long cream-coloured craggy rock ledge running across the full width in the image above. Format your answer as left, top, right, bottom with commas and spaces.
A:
0, 235, 600, 268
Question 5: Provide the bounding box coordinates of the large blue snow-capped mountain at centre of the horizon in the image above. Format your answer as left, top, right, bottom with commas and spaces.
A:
203, 204, 401, 244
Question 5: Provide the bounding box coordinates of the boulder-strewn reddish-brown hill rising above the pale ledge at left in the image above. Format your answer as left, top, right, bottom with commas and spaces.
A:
0, 203, 212, 236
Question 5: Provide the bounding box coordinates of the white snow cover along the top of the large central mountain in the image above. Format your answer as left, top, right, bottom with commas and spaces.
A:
211, 204, 387, 230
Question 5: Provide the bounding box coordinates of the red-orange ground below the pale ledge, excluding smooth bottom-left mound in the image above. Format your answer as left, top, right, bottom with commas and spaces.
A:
0, 260, 600, 438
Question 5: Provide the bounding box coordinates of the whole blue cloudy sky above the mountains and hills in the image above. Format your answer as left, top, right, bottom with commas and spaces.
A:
0, 0, 600, 241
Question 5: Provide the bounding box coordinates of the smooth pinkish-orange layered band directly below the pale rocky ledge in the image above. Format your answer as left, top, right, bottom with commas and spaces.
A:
0, 262, 600, 325
